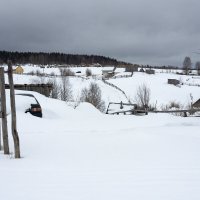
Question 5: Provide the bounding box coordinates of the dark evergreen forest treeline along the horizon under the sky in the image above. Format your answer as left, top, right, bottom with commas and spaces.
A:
0, 51, 131, 66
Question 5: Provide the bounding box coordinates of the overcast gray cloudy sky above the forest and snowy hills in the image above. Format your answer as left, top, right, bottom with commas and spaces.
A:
0, 0, 200, 65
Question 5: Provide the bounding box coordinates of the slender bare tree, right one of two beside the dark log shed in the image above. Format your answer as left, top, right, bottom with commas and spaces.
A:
60, 76, 72, 101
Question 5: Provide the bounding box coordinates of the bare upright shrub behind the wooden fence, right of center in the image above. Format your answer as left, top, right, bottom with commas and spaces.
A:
135, 83, 151, 108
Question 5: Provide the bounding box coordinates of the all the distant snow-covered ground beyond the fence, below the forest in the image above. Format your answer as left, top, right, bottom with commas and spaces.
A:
6, 66, 200, 109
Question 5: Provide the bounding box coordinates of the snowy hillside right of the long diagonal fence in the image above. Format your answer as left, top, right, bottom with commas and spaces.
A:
109, 72, 200, 108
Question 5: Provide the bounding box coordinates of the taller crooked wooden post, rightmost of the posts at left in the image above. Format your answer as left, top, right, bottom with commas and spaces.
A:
8, 60, 20, 158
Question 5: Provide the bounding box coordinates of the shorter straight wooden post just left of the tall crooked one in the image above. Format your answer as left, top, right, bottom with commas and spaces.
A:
0, 67, 10, 154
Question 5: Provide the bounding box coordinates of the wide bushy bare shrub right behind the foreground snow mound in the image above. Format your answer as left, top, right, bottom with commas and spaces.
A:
80, 83, 105, 112
